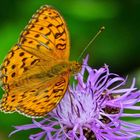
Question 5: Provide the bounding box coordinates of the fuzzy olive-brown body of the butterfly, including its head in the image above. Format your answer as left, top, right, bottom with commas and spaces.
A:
11, 61, 81, 88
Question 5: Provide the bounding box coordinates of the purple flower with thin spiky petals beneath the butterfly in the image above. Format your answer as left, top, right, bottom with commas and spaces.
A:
10, 57, 140, 140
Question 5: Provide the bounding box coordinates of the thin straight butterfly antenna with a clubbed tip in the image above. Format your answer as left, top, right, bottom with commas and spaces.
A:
77, 26, 105, 61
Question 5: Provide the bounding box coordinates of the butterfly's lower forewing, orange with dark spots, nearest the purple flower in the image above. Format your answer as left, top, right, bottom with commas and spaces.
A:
17, 75, 68, 118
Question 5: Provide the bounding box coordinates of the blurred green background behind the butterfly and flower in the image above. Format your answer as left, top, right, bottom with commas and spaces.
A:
0, 0, 140, 140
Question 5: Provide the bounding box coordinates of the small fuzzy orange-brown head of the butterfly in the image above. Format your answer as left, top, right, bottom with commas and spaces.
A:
70, 61, 82, 75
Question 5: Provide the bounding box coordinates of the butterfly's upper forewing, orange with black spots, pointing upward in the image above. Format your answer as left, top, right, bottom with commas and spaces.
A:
18, 6, 70, 60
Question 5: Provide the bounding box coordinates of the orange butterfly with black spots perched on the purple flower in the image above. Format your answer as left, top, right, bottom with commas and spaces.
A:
0, 5, 82, 118
